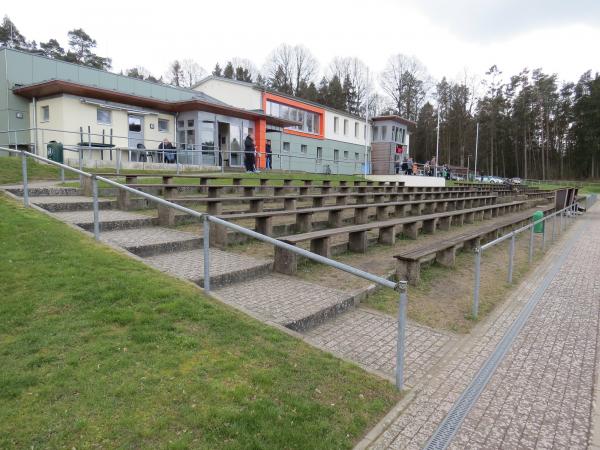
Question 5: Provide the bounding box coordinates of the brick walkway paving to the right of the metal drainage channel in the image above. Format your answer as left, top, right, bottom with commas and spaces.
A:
451, 211, 600, 449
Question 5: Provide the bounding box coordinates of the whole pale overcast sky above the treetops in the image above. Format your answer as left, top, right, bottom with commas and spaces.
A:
0, 0, 600, 88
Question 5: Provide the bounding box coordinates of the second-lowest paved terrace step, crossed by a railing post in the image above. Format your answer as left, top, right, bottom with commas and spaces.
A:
144, 248, 273, 290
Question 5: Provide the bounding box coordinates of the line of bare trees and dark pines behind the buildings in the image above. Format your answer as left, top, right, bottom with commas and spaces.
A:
0, 17, 600, 179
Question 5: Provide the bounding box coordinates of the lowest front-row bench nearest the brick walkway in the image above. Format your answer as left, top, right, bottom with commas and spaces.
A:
394, 206, 552, 285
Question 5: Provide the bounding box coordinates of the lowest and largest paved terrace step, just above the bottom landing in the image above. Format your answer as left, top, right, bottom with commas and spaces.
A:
215, 274, 356, 331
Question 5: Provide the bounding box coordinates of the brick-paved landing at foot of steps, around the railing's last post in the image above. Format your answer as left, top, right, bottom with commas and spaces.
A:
305, 308, 456, 386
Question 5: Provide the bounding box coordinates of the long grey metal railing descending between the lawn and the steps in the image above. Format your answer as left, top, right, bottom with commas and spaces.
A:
0, 147, 408, 389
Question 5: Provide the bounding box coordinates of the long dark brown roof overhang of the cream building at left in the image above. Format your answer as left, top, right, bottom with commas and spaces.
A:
13, 80, 300, 127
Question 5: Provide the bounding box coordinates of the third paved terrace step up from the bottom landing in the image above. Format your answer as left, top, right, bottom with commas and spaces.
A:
100, 227, 203, 257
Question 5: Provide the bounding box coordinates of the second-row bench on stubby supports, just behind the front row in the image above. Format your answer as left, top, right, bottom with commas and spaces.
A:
273, 201, 525, 274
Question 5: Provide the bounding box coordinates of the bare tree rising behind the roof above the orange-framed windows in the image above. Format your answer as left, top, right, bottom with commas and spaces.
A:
263, 44, 319, 95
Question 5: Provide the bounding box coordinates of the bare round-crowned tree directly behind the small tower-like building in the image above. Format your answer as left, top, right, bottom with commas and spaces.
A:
380, 54, 432, 120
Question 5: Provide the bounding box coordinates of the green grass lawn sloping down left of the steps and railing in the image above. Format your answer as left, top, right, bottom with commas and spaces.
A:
0, 196, 400, 449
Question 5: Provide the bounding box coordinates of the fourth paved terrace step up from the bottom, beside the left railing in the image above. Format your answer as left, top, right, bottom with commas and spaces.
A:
54, 209, 158, 232
